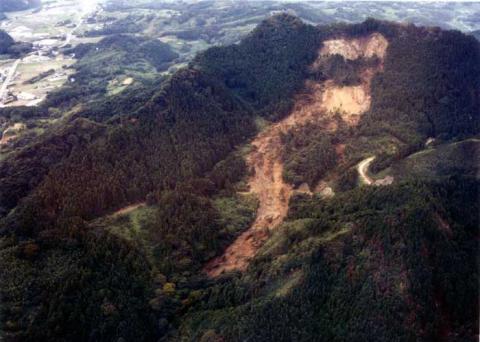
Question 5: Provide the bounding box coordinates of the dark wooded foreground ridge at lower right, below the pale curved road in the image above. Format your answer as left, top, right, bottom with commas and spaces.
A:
180, 179, 479, 341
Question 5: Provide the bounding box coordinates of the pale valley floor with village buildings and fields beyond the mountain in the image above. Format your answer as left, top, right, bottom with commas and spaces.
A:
0, 0, 101, 108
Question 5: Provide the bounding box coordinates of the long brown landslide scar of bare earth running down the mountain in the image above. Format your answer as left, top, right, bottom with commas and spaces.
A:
204, 33, 388, 277
